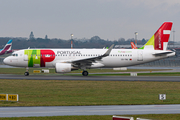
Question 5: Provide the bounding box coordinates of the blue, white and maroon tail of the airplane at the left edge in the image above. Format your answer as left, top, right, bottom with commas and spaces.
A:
0, 40, 13, 55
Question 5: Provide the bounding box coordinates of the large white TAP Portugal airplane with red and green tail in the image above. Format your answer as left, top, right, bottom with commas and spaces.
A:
3, 22, 175, 76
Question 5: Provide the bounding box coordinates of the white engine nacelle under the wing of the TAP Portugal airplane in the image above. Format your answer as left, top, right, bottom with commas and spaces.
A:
55, 63, 71, 73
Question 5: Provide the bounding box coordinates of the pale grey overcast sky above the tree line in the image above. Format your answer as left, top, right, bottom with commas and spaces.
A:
0, 0, 180, 41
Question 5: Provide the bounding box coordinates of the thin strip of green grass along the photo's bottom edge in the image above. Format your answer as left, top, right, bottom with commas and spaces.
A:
0, 114, 180, 120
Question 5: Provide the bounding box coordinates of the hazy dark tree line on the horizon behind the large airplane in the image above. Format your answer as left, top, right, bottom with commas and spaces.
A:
0, 35, 147, 49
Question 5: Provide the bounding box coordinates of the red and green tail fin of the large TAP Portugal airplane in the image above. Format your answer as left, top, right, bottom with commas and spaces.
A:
140, 22, 173, 50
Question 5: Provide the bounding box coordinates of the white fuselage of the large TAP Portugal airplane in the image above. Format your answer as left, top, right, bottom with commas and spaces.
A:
4, 49, 175, 68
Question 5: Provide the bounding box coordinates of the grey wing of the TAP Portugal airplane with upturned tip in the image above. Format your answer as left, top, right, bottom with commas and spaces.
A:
65, 44, 114, 67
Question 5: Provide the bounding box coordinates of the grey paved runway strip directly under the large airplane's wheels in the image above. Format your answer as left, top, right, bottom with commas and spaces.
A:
0, 74, 180, 82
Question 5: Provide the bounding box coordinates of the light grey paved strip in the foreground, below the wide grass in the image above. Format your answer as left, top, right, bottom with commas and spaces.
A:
0, 104, 180, 117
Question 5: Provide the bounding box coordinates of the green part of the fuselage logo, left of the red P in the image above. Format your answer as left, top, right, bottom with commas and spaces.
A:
24, 50, 41, 67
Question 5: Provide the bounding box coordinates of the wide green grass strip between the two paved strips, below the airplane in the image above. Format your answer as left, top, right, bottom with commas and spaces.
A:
0, 80, 180, 106
